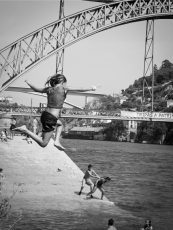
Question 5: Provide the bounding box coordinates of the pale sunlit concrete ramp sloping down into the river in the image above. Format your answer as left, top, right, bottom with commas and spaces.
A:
0, 136, 114, 211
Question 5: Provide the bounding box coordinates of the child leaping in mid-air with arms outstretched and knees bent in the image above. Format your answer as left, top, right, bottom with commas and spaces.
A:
13, 74, 97, 150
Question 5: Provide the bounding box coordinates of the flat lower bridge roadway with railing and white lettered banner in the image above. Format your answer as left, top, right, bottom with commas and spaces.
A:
0, 107, 173, 122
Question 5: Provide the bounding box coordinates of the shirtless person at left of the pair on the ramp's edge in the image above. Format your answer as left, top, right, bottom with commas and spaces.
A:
79, 165, 100, 196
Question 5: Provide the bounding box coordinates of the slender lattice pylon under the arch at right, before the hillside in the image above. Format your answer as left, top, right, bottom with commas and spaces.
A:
142, 19, 154, 112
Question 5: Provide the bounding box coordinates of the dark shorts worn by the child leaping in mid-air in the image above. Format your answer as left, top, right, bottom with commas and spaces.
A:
40, 111, 58, 132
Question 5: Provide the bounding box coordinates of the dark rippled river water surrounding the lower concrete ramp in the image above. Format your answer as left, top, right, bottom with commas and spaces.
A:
4, 139, 173, 230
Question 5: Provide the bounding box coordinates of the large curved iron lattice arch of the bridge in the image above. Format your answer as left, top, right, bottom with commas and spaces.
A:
0, 0, 173, 92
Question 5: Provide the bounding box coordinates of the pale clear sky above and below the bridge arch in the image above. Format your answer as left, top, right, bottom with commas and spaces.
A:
0, 0, 173, 106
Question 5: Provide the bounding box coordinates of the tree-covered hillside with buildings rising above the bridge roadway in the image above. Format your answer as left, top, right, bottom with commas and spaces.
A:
86, 60, 173, 112
